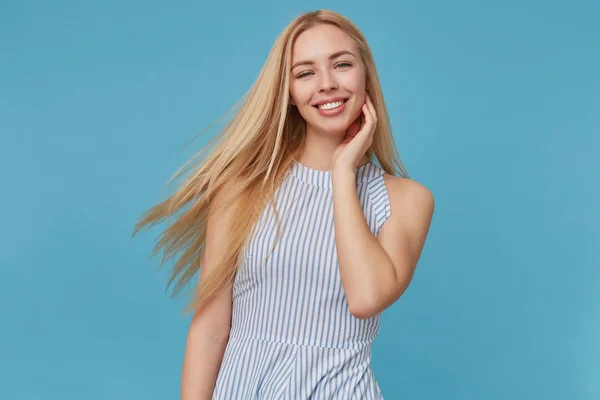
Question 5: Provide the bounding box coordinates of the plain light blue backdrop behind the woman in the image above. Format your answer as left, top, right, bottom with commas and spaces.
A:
0, 0, 600, 400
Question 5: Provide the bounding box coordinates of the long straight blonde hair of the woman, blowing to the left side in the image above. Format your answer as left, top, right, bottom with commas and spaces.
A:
132, 10, 408, 312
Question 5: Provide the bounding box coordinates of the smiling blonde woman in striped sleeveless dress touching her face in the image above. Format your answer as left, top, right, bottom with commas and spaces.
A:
134, 10, 434, 400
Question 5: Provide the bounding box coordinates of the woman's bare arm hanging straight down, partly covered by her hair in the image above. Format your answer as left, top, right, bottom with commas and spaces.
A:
181, 181, 237, 400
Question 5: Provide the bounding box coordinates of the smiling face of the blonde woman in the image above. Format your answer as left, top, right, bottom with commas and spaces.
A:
290, 24, 365, 137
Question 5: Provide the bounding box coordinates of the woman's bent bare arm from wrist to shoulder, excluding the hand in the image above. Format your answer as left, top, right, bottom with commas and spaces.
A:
333, 171, 434, 318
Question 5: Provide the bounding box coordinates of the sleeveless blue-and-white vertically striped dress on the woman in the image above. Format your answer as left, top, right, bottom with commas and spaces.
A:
212, 161, 390, 400
